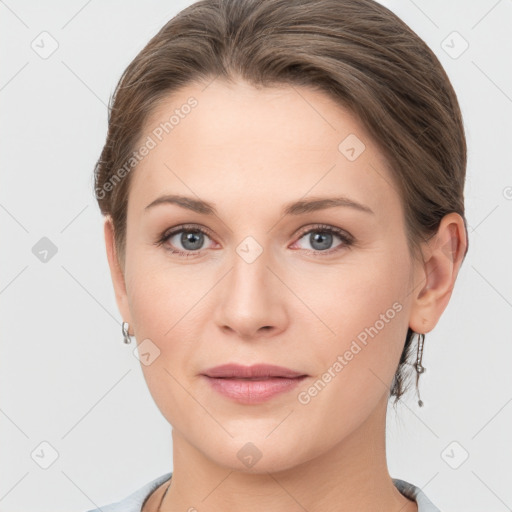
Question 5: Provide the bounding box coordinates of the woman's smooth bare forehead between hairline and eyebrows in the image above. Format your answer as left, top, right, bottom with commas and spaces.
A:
129, 80, 399, 216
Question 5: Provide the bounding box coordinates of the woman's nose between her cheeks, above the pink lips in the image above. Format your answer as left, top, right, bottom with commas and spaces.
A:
215, 247, 289, 340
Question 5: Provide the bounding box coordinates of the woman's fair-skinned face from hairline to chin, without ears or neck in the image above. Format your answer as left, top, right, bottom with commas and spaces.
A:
107, 81, 420, 471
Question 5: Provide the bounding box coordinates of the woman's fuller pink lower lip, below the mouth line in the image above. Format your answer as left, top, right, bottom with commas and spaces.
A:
204, 375, 306, 404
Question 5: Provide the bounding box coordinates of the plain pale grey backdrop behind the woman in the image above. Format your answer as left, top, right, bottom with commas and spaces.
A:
0, 0, 512, 512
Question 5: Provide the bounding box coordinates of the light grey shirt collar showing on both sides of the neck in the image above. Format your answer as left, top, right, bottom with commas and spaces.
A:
87, 472, 440, 512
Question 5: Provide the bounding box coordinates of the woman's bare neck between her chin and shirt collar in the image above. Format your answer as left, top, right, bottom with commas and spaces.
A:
160, 397, 417, 512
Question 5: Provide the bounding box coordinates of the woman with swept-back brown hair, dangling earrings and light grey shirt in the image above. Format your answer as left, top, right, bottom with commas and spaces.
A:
87, 0, 468, 512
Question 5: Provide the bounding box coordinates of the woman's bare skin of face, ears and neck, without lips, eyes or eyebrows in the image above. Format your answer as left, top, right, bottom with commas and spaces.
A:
104, 80, 466, 512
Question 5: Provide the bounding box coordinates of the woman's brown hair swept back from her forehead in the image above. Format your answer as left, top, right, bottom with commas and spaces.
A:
94, 0, 467, 403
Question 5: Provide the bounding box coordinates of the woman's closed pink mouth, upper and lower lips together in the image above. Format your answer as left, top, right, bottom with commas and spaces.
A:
201, 363, 308, 404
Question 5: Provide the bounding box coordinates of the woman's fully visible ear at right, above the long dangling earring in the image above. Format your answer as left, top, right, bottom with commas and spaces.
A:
409, 212, 467, 333
